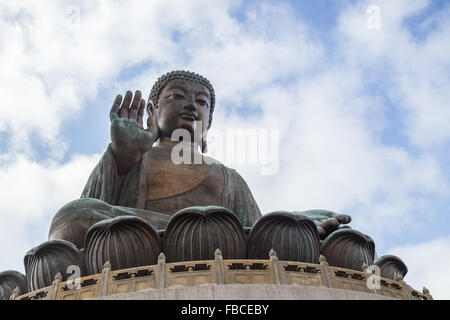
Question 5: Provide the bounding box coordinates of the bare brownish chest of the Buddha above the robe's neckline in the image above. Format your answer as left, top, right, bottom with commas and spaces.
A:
145, 149, 214, 200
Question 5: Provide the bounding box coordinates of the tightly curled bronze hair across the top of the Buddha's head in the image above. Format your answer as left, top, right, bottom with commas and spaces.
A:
149, 70, 216, 129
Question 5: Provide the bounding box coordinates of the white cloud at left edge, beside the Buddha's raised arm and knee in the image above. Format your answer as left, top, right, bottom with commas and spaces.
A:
0, 154, 100, 272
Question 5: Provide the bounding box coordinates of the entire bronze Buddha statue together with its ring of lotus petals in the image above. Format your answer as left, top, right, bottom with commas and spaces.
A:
0, 71, 407, 296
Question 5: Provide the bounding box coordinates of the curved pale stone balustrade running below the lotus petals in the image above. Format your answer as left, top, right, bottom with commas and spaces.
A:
11, 250, 432, 300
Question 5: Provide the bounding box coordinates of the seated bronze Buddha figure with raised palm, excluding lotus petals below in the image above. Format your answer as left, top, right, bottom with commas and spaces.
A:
49, 71, 261, 248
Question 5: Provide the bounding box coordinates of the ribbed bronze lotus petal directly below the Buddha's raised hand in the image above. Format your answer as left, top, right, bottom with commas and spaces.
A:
84, 216, 161, 274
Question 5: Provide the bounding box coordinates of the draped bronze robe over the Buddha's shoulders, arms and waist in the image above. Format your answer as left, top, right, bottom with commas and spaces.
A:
69, 146, 261, 228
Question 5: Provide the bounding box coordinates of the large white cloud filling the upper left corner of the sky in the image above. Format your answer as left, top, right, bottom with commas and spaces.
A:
0, 1, 239, 152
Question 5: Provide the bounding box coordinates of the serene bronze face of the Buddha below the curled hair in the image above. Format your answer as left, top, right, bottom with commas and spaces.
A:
149, 79, 211, 137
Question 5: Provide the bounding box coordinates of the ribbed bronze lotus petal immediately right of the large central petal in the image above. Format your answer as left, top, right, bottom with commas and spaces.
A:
248, 211, 320, 263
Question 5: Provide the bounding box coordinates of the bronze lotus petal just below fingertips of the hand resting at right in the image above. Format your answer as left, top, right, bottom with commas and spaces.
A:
321, 229, 375, 271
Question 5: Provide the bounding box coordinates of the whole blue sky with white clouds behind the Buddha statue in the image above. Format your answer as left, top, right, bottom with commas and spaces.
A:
0, 0, 450, 298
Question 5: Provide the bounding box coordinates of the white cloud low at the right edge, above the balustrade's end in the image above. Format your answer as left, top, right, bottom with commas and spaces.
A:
389, 237, 450, 300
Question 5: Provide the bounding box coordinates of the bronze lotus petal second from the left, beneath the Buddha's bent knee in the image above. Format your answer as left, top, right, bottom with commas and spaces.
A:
24, 240, 86, 291
